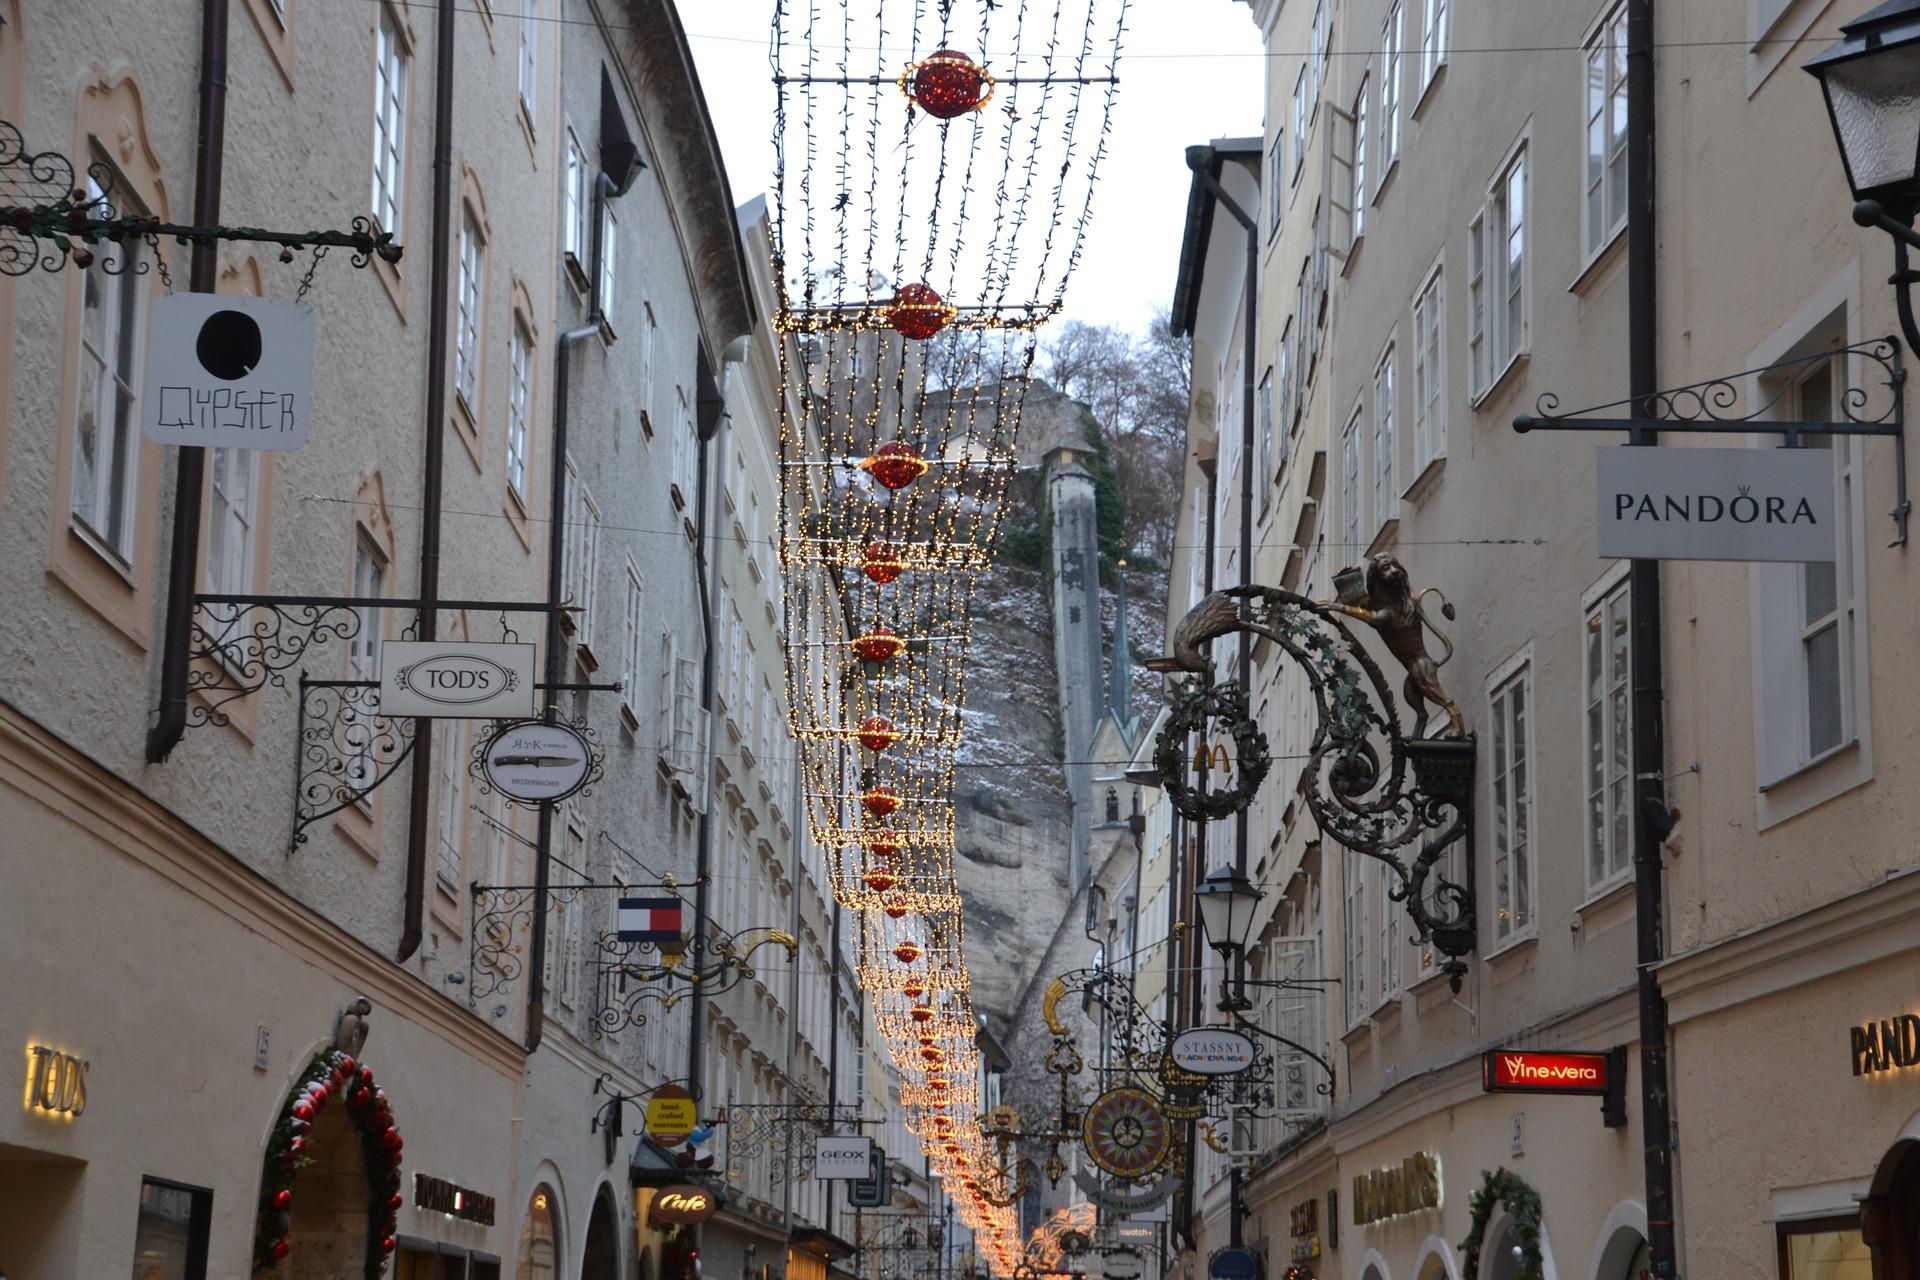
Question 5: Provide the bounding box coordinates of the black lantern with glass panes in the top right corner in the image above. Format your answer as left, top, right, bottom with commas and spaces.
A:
1807, 0, 1920, 349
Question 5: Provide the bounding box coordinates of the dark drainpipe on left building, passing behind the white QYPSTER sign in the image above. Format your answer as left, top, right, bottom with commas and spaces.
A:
146, 0, 228, 764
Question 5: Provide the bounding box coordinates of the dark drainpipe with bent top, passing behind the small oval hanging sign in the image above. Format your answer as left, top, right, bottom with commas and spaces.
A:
526, 169, 639, 1054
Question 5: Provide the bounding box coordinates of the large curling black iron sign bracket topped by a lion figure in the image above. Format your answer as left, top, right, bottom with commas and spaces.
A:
1156, 557, 1476, 990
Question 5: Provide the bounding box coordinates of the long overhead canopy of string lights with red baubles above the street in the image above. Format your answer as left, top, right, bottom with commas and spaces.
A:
772, 0, 1127, 1276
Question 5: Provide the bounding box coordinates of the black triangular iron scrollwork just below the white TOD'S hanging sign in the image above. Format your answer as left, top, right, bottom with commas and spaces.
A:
288, 674, 415, 852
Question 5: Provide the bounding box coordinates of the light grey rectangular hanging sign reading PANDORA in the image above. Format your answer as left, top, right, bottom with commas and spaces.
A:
1596, 445, 1836, 560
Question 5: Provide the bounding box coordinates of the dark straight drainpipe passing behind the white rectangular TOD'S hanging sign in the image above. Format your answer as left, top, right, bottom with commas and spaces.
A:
394, 0, 453, 961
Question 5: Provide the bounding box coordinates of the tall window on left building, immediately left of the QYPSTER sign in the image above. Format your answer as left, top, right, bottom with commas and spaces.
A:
73, 159, 146, 568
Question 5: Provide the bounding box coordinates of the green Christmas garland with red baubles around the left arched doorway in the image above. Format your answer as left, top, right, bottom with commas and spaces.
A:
253, 1050, 405, 1280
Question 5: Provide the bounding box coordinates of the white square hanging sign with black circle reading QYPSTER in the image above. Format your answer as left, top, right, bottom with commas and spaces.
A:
140, 294, 313, 449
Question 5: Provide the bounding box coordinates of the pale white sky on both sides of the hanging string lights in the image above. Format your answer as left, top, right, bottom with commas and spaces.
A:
680, 0, 1263, 332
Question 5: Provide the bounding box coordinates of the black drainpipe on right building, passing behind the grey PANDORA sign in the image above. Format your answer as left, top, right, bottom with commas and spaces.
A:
1626, 0, 1678, 1280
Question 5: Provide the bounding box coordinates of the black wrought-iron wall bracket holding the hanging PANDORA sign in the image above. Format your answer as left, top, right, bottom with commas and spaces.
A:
1513, 334, 1912, 547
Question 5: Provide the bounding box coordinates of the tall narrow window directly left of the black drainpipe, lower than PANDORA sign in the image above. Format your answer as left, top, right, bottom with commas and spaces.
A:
1584, 578, 1632, 889
